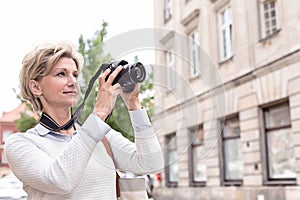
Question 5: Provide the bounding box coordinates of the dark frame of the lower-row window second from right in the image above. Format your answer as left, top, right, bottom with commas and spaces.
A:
219, 113, 243, 186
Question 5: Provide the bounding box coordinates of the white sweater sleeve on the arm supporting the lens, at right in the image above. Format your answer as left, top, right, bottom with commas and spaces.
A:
106, 109, 164, 174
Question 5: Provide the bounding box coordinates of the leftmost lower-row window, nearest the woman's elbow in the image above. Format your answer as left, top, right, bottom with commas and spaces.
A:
166, 134, 178, 186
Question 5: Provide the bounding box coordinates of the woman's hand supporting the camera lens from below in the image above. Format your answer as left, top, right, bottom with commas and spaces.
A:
120, 83, 142, 110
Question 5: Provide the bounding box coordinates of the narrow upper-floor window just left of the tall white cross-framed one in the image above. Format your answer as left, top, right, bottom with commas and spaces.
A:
189, 31, 200, 78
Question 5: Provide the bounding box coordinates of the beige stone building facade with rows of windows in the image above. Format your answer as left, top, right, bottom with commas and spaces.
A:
152, 0, 300, 200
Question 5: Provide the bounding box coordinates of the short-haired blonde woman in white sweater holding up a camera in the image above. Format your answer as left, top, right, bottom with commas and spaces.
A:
5, 42, 163, 200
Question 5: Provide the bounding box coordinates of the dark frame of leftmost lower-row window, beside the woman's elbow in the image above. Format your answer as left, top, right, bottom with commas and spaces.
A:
165, 133, 179, 187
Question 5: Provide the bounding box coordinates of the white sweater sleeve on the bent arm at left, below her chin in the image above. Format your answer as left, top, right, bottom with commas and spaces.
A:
4, 115, 110, 194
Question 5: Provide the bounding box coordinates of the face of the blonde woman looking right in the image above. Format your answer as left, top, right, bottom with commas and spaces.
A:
39, 57, 80, 108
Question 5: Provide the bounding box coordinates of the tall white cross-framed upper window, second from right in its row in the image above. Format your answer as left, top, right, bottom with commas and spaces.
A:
218, 5, 233, 61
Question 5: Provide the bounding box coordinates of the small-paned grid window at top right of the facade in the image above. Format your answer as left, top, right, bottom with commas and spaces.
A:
260, 0, 279, 38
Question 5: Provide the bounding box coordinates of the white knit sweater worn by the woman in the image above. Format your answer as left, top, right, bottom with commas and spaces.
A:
4, 110, 164, 200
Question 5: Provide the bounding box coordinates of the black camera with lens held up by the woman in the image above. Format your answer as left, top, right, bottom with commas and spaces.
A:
105, 60, 146, 92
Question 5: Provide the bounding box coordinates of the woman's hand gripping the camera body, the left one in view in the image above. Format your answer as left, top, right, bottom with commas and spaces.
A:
93, 66, 123, 121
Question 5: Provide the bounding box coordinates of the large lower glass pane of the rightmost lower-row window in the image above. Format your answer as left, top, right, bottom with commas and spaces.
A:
267, 128, 296, 179
